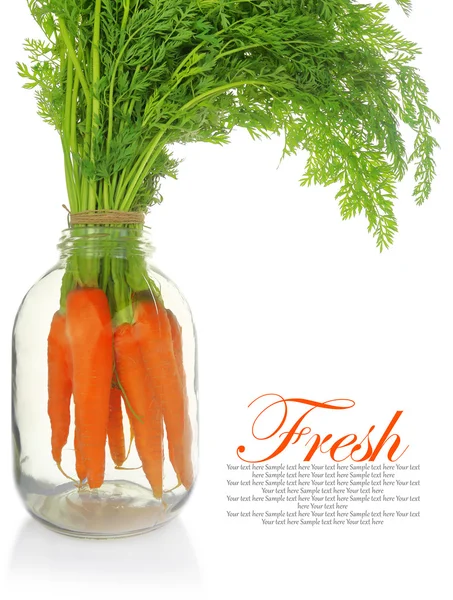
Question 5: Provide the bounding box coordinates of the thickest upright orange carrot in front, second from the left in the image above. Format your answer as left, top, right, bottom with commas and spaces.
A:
66, 288, 113, 488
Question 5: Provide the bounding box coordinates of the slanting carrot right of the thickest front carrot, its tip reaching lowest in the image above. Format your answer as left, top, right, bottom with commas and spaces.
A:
114, 323, 163, 498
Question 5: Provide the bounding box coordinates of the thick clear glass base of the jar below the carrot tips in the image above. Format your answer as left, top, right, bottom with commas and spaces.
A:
25, 481, 188, 539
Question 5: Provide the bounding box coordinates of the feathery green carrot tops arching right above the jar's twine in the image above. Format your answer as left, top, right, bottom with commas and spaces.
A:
19, 0, 438, 249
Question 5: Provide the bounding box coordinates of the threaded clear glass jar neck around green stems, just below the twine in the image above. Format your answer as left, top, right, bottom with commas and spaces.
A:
58, 225, 154, 262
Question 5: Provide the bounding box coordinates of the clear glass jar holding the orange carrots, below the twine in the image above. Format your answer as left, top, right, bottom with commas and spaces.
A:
13, 226, 198, 538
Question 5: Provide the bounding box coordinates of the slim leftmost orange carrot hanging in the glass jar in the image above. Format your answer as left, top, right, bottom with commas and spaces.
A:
47, 312, 72, 464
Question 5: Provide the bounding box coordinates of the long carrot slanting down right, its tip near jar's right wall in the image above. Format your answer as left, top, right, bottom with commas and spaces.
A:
135, 301, 193, 489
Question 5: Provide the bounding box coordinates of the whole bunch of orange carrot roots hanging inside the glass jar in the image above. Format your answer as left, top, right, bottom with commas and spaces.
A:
48, 287, 193, 499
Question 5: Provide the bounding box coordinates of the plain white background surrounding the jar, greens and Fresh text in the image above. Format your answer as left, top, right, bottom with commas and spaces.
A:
0, 0, 453, 600
